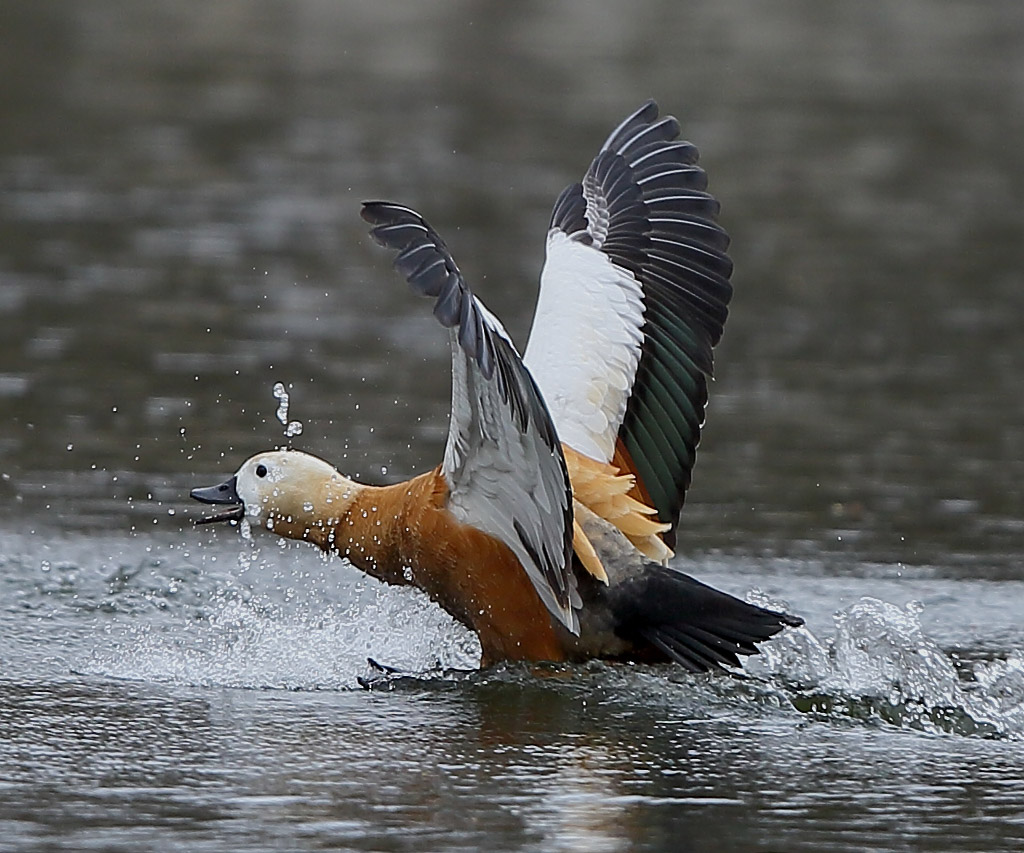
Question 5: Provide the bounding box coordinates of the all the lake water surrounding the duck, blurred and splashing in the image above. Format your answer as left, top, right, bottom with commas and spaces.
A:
0, 0, 1024, 851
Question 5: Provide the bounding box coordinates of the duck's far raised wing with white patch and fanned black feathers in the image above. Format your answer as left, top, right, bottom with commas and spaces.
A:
523, 100, 732, 546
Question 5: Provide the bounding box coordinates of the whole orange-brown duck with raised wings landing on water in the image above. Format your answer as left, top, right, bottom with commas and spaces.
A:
190, 100, 803, 673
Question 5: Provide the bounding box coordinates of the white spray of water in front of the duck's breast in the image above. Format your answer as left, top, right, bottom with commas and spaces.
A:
80, 588, 479, 690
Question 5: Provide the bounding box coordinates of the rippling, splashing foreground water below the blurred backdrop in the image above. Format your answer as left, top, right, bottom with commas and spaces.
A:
6, 534, 1024, 851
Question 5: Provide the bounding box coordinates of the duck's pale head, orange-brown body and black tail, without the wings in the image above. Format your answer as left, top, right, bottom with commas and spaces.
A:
193, 451, 800, 672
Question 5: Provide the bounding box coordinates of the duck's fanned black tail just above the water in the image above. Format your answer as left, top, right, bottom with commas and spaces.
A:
609, 563, 804, 673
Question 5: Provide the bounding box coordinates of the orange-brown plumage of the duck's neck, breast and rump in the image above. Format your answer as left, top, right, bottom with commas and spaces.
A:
254, 438, 671, 665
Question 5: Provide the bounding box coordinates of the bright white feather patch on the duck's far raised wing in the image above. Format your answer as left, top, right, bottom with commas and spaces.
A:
523, 228, 644, 462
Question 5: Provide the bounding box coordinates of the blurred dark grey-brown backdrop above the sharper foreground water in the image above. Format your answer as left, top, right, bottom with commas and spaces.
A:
0, 0, 1024, 574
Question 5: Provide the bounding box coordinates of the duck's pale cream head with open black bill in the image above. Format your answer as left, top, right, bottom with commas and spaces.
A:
189, 451, 360, 539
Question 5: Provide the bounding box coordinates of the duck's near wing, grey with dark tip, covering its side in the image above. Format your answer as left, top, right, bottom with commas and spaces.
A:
362, 202, 581, 633
